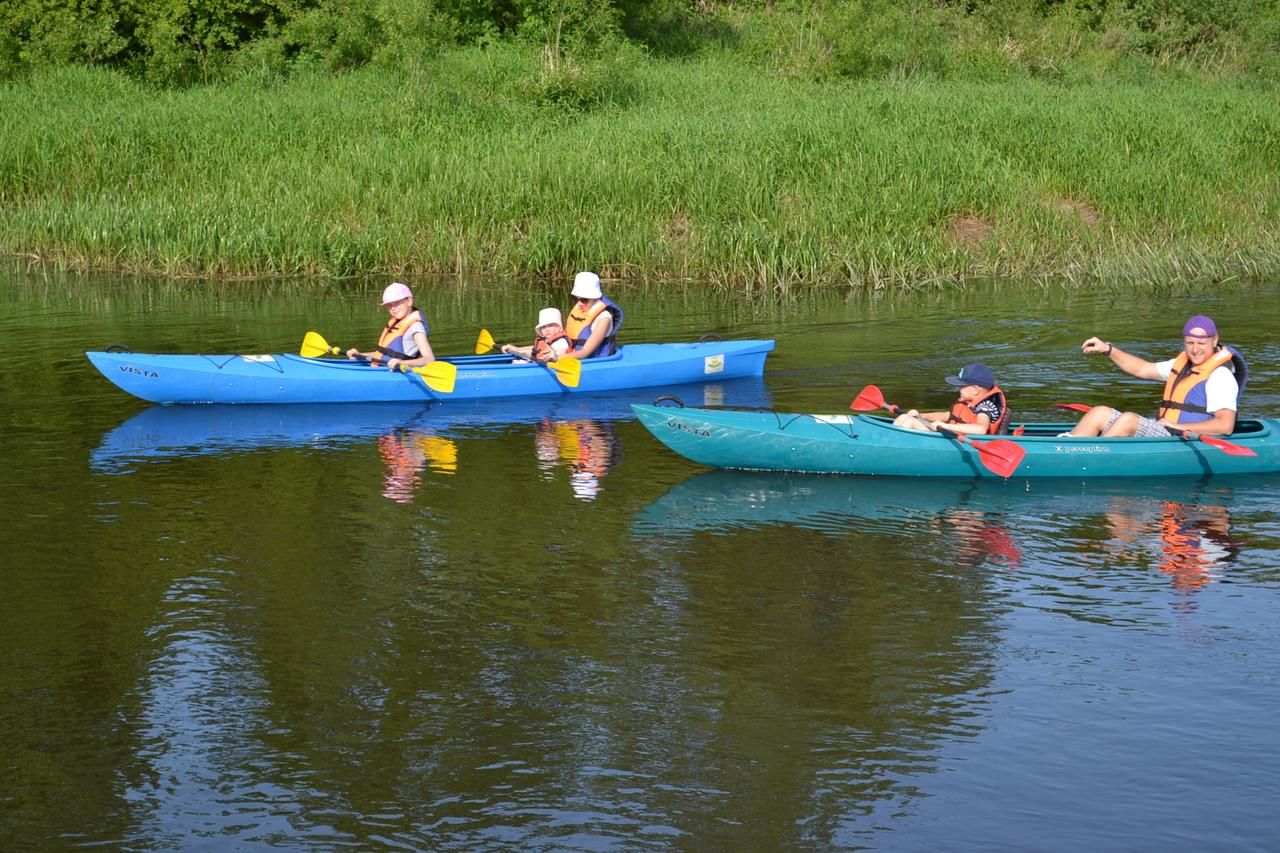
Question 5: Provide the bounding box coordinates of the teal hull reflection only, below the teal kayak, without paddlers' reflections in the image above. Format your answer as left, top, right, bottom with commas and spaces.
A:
634, 471, 1280, 535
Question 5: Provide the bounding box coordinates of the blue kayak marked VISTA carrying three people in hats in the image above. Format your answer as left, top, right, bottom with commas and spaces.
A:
86, 341, 773, 403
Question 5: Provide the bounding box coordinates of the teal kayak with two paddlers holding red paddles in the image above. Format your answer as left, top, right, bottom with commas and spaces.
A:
632, 405, 1280, 479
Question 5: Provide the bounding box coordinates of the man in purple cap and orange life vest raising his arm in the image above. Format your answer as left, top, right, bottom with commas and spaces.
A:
1064, 314, 1249, 437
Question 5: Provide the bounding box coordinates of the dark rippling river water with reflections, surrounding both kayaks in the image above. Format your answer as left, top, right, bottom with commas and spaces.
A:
0, 270, 1280, 850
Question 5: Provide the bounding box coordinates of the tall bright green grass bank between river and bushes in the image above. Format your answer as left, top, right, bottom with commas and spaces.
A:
0, 44, 1280, 289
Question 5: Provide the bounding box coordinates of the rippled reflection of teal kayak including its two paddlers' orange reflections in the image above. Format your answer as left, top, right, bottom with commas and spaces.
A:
632, 471, 1280, 596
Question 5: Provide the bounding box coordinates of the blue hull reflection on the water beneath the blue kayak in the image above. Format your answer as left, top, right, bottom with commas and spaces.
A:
90, 377, 769, 471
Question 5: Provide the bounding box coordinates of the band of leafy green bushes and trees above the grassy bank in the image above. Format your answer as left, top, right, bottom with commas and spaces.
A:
0, 0, 1280, 86
